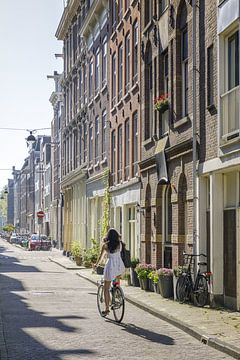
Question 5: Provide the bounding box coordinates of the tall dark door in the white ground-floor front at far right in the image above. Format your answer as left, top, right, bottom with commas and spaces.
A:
223, 209, 237, 298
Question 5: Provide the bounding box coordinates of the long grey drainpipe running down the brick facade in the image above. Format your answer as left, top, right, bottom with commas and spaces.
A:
192, 0, 197, 274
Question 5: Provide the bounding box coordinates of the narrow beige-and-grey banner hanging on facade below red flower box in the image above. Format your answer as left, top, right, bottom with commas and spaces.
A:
155, 136, 169, 185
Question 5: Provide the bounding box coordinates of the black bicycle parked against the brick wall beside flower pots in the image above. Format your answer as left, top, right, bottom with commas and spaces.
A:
176, 253, 211, 307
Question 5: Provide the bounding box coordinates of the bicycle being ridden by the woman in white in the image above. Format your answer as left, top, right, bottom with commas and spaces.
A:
97, 272, 125, 323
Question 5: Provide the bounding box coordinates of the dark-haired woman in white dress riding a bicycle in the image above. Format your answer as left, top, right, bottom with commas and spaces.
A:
95, 229, 125, 315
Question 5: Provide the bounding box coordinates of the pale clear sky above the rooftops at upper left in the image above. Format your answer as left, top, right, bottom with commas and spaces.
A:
0, 0, 64, 189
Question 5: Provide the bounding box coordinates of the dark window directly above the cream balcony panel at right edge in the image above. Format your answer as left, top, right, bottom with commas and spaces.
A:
228, 31, 239, 90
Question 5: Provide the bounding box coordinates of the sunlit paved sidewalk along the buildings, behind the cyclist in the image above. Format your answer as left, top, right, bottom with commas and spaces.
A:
50, 249, 240, 359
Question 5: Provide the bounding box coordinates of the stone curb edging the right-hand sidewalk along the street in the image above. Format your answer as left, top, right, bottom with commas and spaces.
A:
76, 273, 240, 359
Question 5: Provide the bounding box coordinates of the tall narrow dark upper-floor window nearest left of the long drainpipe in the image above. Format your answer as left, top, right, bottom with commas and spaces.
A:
181, 29, 188, 117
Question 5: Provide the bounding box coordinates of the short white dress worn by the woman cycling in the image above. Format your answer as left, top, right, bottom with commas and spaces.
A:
103, 244, 125, 281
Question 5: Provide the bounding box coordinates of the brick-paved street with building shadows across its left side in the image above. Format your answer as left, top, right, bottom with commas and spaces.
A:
0, 240, 231, 360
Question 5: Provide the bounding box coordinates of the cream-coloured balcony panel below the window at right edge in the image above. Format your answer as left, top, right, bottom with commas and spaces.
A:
220, 86, 240, 140
